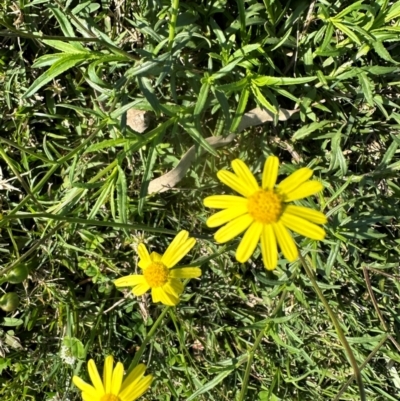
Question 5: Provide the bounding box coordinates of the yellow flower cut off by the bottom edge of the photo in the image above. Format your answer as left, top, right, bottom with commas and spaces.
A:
72, 355, 153, 401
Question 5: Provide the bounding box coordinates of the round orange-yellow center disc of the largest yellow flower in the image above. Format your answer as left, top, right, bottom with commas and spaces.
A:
247, 189, 282, 224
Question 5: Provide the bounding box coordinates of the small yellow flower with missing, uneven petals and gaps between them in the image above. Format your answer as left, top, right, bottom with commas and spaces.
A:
114, 231, 201, 306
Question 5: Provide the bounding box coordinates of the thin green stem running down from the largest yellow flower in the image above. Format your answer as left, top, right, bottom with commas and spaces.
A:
299, 251, 366, 401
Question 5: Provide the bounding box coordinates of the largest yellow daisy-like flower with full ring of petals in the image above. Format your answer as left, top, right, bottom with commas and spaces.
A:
204, 156, 327, 270
